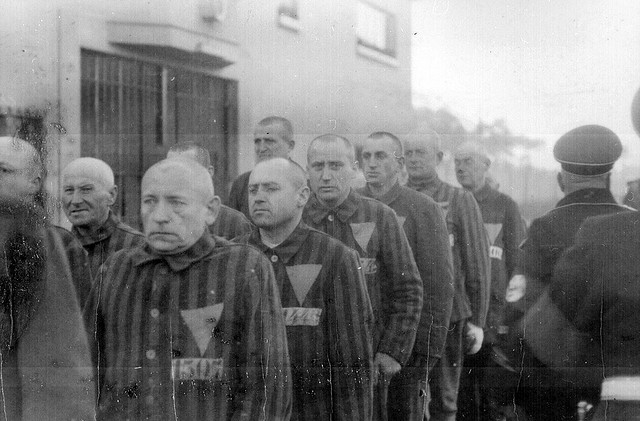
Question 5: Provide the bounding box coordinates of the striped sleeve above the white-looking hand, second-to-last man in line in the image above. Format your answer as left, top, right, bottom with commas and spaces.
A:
456, 191, 491, 327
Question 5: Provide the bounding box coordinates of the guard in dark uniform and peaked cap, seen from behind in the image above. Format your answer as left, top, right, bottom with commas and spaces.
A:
508, 125, 627, 420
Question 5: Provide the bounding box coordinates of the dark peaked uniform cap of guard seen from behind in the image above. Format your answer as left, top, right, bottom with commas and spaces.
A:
553, 124, 622, 175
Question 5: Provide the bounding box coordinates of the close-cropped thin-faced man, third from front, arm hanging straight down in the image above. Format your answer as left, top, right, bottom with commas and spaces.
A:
303, 135, 423, 419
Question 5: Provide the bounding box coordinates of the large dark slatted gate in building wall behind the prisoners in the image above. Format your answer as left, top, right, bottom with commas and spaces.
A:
81, 50, 237, 226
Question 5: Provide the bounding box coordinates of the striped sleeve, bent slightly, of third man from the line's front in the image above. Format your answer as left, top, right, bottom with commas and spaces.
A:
376, 206, 423, 364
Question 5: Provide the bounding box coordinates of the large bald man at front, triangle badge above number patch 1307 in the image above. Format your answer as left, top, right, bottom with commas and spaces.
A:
85, 159, 291, 421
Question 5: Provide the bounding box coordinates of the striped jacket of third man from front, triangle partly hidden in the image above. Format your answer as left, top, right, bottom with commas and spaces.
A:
303, 191, 422, 364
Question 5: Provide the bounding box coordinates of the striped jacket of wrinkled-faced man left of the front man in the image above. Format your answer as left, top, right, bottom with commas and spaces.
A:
71, 211, 144, 279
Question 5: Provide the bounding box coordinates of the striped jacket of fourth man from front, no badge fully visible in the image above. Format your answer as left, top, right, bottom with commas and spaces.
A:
359, 183, 453, 357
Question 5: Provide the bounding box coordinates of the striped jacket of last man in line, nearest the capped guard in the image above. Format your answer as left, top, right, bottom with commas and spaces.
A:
473, 184, 525, 343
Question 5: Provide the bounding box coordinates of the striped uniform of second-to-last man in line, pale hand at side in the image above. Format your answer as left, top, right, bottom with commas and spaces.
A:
407, 176, 491, 420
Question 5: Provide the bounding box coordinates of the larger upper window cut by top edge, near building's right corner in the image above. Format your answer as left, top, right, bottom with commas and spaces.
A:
356, 1, 396, 58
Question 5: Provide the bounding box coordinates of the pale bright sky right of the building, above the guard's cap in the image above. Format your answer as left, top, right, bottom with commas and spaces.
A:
412, 0, 640, 172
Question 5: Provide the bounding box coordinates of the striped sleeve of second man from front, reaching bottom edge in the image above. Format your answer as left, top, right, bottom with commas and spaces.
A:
327, 247, 373, 421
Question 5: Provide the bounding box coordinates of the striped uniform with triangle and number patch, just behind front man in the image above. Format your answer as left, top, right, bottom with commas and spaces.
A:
236, 222, 373, 421
